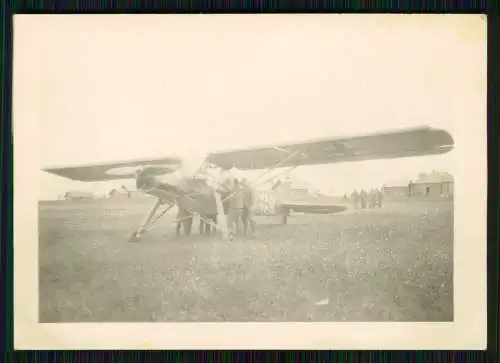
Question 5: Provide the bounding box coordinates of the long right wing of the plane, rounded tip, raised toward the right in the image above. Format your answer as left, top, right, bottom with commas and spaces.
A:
207, 126, 454, 170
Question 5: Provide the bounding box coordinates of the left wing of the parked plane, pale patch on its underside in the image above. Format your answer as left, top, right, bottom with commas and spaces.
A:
43, 156, 181, 182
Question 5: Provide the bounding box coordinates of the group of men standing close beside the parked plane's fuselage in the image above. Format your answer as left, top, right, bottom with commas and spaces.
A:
176, 179, 255, 236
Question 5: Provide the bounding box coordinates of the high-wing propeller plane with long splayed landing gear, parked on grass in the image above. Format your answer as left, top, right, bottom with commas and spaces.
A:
43, 126, 454, 241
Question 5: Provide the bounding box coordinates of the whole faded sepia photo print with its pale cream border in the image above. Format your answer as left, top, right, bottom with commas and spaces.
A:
13, 14, 486, 349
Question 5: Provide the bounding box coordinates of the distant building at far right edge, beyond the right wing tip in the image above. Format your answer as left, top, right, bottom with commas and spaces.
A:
411, 170, 454, 198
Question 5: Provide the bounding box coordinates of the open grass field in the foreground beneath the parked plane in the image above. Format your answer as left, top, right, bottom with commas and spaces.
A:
39, 201, 453, 322
